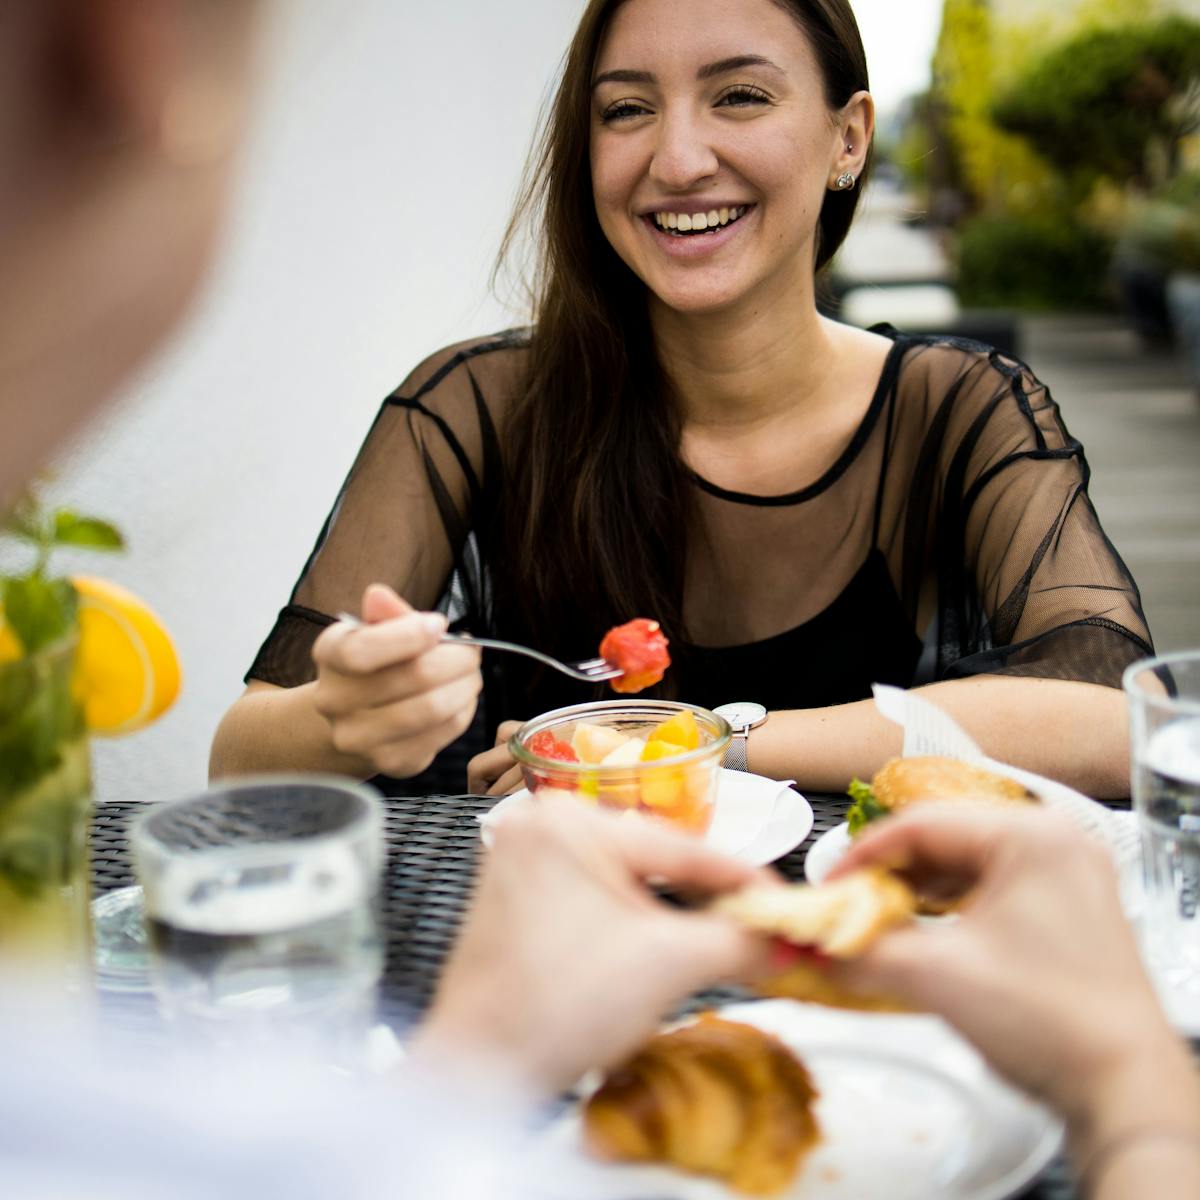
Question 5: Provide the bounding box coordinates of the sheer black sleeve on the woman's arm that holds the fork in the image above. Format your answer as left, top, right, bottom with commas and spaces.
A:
246, 332, 524, 688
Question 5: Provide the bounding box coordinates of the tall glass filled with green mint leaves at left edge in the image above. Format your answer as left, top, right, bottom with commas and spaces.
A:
0, 636, 91, 995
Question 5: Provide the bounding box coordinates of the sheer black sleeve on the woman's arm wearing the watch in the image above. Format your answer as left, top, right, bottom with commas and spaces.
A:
916, 352, 1152, 688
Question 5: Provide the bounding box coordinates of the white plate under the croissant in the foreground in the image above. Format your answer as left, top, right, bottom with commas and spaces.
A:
538, 1001, 1062, 1200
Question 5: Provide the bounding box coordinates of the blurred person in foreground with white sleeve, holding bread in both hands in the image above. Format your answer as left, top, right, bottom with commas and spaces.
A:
0, 0, 1200, 1200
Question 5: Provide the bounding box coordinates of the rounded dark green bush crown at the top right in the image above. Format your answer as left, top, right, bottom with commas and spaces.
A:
992, 17, 1200, 180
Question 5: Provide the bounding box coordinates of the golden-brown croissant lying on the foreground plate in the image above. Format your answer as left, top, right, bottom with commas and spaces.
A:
583, 1014, 820, 1196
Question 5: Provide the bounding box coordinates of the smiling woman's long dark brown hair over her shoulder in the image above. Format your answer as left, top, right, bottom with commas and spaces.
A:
492, 0, 868, 667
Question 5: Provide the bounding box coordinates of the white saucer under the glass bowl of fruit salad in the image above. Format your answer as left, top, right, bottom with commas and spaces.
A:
479, 767, 812, 866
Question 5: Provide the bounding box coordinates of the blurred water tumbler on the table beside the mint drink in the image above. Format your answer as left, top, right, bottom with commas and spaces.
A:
130, 775, 383, 1057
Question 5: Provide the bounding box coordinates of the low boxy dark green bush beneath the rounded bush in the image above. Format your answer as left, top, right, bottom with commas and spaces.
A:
958, 216, 1112, 310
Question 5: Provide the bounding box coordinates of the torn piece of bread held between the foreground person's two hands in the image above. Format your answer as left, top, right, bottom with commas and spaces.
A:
714, 868, 917, 1013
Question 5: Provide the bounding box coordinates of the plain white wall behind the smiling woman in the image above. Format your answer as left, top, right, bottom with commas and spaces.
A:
45, 0, 582, 799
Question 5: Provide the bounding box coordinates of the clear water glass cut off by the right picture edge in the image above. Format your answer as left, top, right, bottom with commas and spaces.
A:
1124, 650, 1200, 1033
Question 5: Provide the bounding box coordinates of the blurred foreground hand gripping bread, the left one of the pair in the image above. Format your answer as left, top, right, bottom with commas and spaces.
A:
418, 799, 766, 1092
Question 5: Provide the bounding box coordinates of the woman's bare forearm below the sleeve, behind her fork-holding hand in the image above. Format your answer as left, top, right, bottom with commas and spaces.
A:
209, 683, 376, 780
